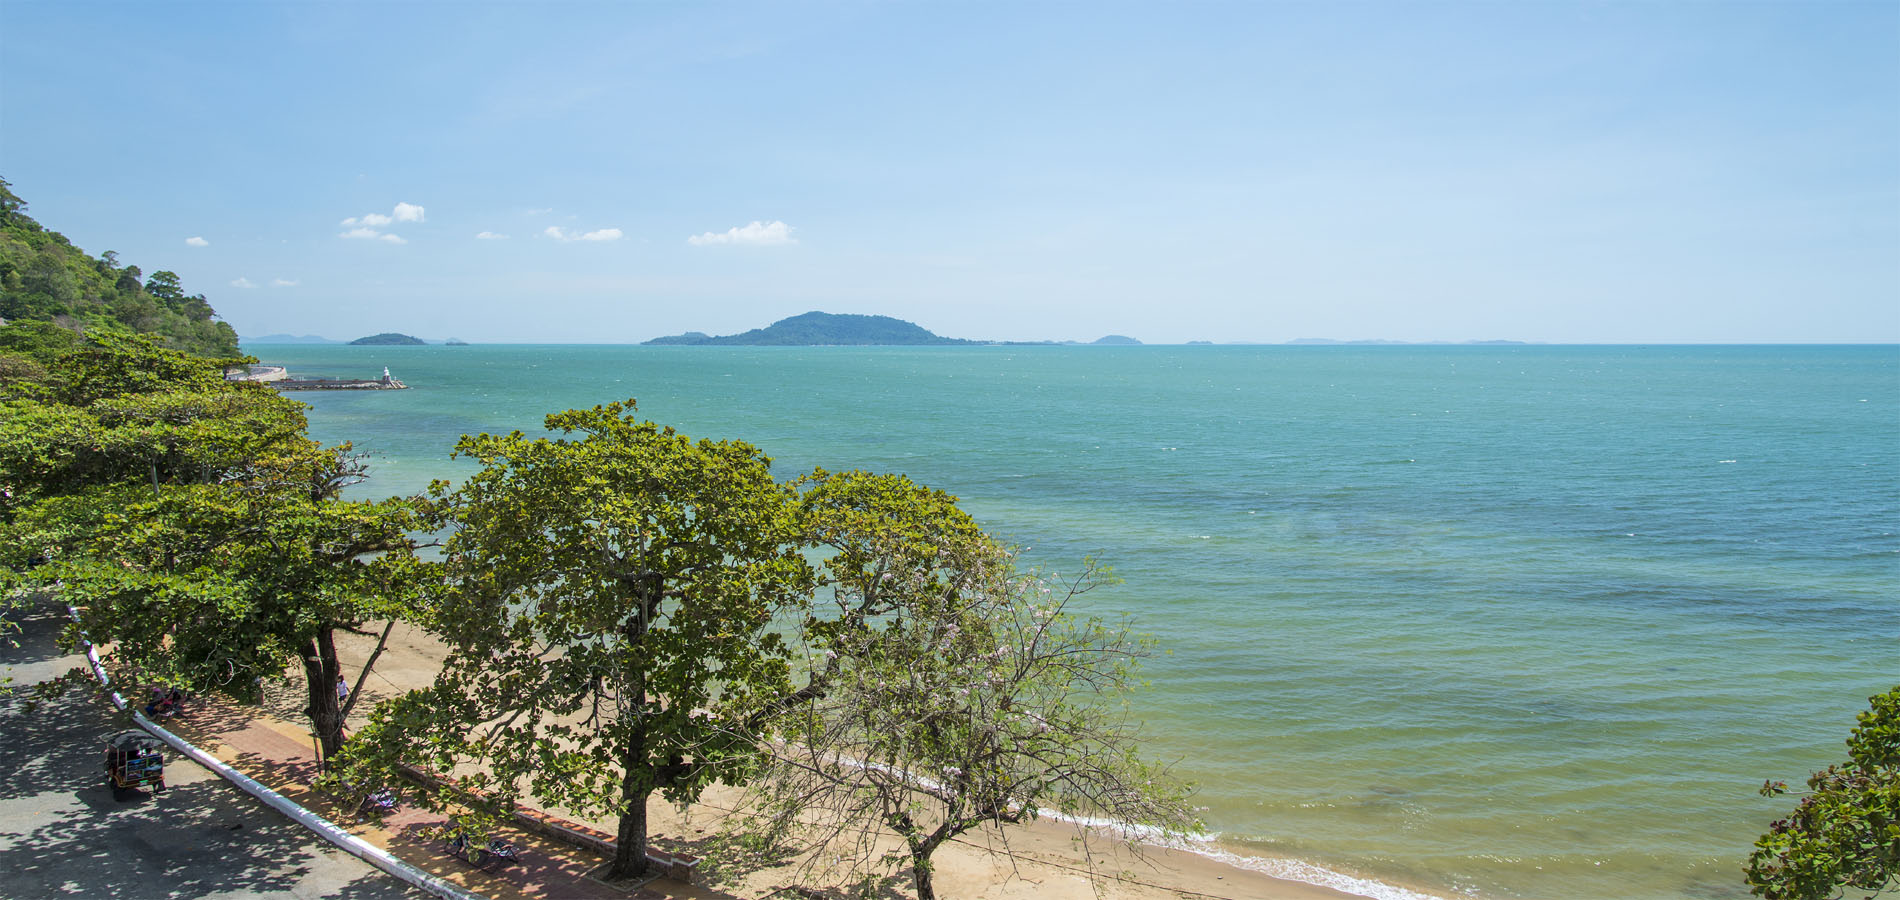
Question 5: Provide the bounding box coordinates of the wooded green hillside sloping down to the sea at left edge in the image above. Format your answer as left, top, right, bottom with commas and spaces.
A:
0, 180, 238, 357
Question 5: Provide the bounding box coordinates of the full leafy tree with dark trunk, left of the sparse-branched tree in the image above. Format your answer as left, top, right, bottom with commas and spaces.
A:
350, 401, 811, 879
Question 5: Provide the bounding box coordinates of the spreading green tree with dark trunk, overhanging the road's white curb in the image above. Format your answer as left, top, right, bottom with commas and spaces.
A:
13, 450, 431, 756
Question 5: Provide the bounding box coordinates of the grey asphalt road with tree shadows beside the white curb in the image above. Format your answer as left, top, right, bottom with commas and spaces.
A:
0, 609, 426, 900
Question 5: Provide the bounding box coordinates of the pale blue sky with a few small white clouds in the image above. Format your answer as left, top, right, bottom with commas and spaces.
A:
0, 0, 1900, 344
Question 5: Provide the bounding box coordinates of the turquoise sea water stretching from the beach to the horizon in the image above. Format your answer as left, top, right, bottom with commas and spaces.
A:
247, 346, 1900, 898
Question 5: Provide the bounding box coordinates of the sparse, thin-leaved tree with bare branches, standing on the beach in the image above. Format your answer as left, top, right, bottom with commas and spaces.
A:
752, 545, 1193, 900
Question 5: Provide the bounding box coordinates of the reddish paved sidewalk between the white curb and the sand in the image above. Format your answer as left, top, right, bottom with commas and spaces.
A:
152, 697, 730, 900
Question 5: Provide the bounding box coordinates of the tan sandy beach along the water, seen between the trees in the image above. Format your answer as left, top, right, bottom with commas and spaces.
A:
281, 625, 1357, 900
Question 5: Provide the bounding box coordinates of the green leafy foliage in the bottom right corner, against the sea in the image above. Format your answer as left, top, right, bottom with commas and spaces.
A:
1746, 685, 1900, 900
